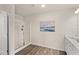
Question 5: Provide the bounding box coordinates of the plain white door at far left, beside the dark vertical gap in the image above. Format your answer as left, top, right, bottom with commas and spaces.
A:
0, 11, 7, 55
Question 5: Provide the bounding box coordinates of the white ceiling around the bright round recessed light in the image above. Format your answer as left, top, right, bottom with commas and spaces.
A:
15, 4, 79, 16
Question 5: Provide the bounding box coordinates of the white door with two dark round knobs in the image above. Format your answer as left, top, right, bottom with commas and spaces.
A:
15, 17, 25, 51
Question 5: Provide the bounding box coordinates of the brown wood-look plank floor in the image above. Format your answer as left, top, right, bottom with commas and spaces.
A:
16, 45, 65, 55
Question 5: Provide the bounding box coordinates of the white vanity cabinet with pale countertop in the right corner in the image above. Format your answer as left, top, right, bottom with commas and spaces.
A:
65, 37, 79, 55
